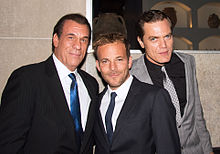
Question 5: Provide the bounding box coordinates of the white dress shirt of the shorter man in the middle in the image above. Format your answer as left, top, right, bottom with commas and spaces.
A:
99, 75, 133, 131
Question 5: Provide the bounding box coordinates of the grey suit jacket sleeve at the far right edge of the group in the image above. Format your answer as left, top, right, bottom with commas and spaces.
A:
191, 58, 213, 154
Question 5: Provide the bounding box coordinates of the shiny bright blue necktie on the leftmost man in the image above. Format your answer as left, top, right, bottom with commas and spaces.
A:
69, 73, 83, 143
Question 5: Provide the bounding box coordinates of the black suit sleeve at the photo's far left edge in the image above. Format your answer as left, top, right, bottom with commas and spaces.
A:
0, 70, 33, 154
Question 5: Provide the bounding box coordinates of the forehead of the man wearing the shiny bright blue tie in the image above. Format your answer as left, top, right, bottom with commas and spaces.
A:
63, 20, 89, 35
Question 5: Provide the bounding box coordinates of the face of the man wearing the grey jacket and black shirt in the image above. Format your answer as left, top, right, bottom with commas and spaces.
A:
138, 19, 173, 66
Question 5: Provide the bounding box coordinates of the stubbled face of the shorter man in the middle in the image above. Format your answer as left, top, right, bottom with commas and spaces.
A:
96, 42, 132, 90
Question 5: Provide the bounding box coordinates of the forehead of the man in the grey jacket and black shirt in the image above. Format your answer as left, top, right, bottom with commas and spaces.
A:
143, 19, 171, 36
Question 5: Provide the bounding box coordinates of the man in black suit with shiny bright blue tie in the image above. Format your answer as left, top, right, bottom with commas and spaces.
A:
0, 14, 98, 154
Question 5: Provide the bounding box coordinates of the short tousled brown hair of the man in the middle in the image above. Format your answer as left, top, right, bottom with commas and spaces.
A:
92, 33, 130, 60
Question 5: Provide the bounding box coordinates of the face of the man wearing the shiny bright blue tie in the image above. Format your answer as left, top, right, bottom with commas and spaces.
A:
53, 20, 89, 71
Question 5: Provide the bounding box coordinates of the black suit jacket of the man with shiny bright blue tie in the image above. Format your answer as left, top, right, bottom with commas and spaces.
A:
0, 56, 98, 154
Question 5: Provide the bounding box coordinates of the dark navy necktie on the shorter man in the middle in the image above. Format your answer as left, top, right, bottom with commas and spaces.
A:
105, 92, 117, 143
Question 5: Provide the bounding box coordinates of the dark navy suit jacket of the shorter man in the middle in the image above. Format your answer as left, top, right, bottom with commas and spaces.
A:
94, 77, 180, 154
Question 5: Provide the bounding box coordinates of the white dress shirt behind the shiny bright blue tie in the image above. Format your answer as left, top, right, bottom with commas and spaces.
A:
53, 54, 91, 130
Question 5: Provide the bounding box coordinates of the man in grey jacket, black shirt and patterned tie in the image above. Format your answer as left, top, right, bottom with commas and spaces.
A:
130, 10, 213, 154
